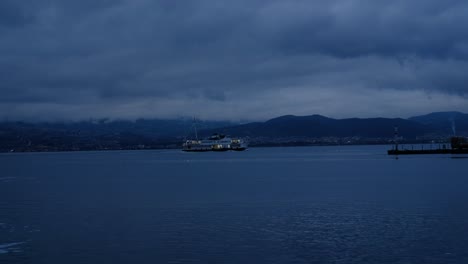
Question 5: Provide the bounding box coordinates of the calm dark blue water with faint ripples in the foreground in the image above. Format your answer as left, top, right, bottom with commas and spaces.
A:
0, 146, 468, 264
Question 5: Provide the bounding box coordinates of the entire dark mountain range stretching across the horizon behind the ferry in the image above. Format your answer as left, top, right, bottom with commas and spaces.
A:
0, 112, 468, 152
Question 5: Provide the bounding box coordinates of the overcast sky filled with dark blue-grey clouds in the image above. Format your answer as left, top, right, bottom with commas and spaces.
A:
0, 0, 468, 121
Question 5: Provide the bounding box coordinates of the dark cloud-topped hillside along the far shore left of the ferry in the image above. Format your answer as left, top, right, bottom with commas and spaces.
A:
0, 119, 233, 152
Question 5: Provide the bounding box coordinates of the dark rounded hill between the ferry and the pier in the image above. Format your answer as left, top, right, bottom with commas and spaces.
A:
203, 115, 438, 138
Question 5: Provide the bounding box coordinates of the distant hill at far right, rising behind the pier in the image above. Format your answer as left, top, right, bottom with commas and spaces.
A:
408, 112, 468, 135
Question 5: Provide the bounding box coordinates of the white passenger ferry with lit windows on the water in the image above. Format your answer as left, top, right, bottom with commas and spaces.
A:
182, 134, 248, 152
